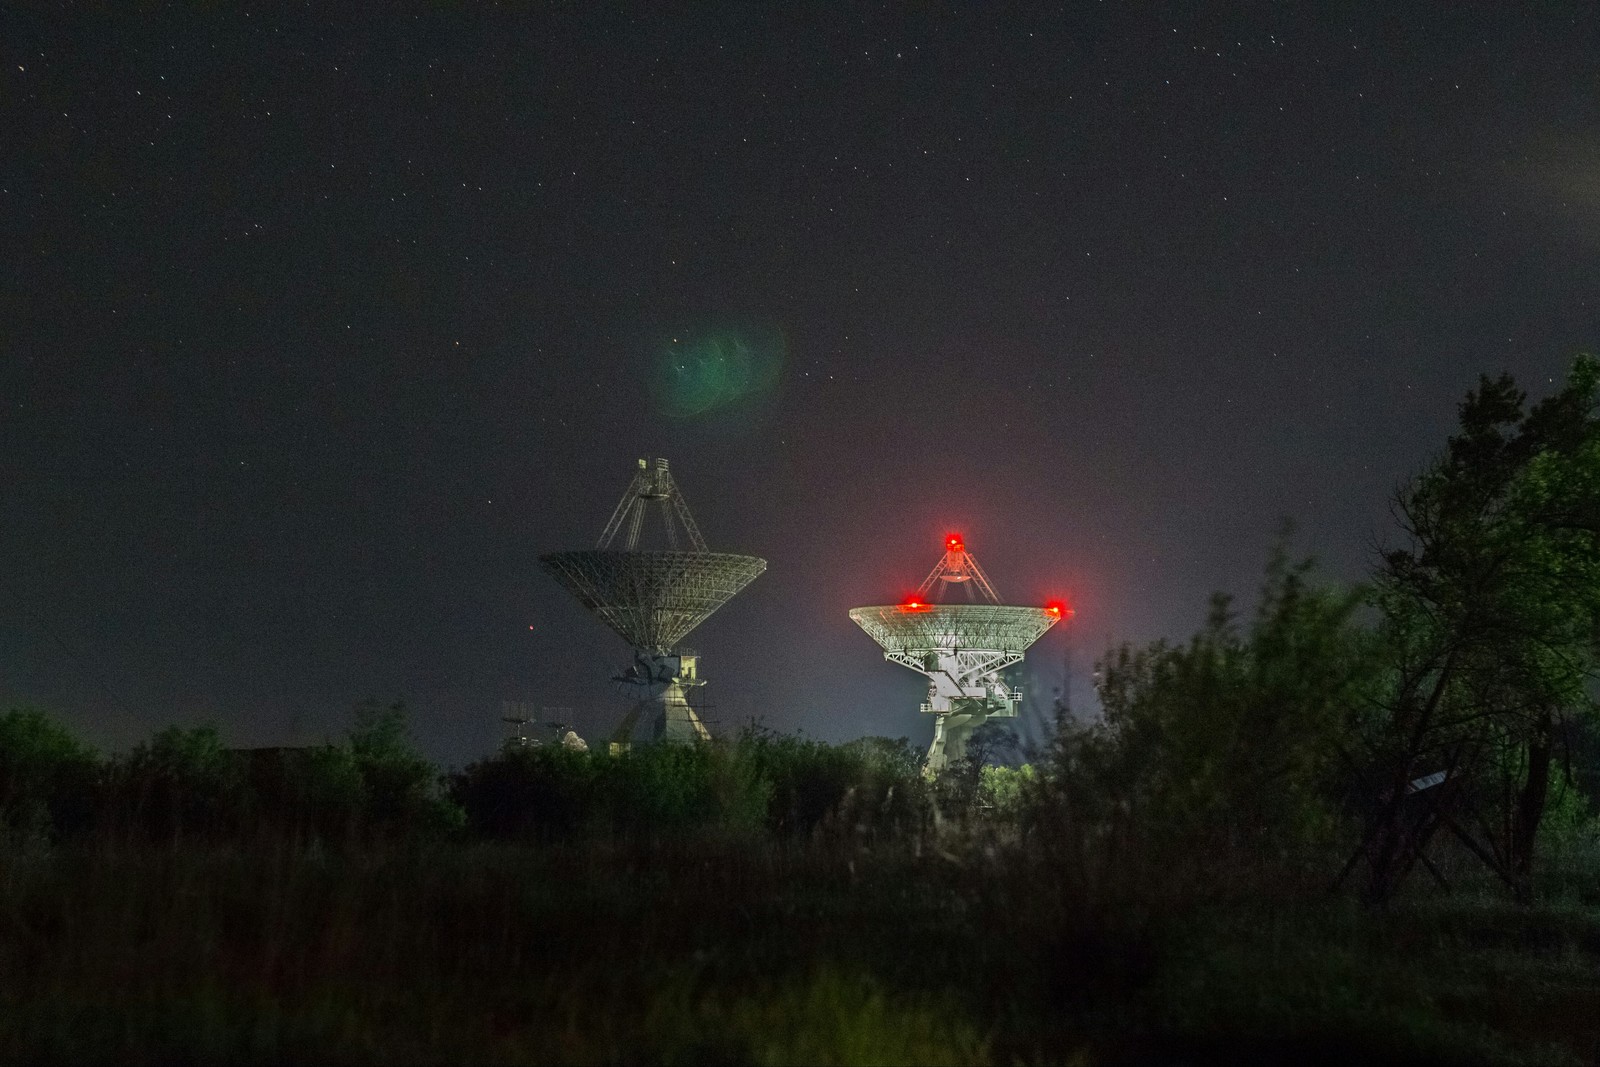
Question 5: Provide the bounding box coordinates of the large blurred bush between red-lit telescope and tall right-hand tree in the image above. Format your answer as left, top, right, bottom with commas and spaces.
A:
1030, 550, 1371, 886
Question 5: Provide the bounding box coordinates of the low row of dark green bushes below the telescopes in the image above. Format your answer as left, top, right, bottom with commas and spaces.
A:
0, 702, 1030, 846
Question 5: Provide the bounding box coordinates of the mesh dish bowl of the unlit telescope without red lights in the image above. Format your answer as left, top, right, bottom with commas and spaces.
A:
539, 549, 766, 653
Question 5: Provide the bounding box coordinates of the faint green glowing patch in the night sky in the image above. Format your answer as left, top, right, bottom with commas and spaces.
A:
651, 330, 786, 419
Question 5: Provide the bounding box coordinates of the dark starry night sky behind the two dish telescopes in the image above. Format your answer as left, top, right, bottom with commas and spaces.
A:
0, 3, 1600, 765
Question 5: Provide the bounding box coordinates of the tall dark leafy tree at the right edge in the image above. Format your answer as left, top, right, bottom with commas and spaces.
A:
1365, 357, 1600, 901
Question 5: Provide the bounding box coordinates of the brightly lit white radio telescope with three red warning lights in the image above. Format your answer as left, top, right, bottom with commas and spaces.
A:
850, 534, 1070, 773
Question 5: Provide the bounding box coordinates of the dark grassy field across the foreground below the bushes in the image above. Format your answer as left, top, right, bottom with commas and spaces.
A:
9, 841, 1600, 1064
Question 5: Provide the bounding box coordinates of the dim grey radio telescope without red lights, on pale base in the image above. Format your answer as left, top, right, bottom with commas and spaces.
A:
539, 459, 766, 750
